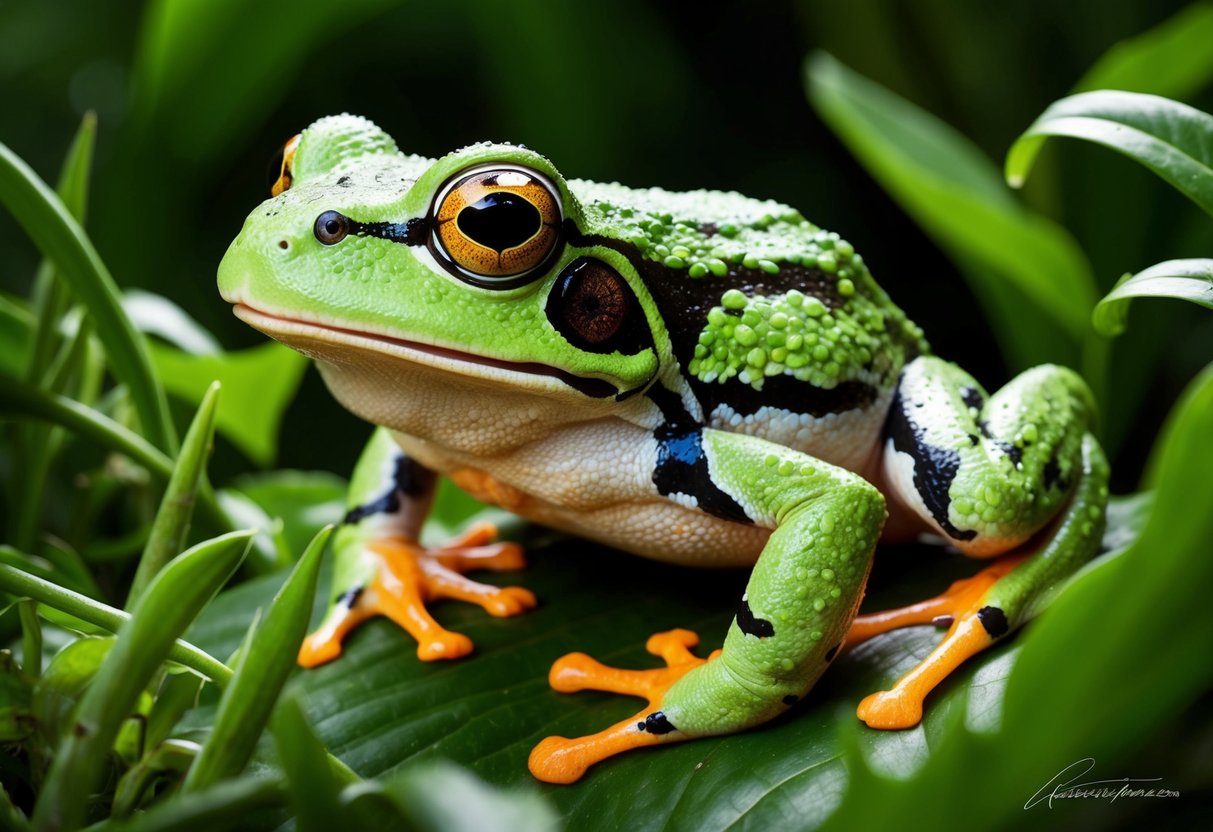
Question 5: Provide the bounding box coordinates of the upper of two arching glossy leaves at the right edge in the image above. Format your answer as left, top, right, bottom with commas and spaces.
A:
1006, 90, 1213, 215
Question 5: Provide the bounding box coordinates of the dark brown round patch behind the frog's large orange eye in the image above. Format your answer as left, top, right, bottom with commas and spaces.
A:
546, 257, 651, 355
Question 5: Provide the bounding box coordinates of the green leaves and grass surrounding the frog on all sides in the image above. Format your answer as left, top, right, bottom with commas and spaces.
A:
0, 0, 1213, 830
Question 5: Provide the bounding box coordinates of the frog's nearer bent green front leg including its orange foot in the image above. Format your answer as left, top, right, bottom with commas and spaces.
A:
530, 429, 885, 782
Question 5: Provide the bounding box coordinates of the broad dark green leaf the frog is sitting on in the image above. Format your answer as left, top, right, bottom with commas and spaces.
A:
177, 489, 1154, 830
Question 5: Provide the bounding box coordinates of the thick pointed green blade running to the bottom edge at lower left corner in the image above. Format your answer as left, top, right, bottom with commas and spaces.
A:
34, 531, 252, 832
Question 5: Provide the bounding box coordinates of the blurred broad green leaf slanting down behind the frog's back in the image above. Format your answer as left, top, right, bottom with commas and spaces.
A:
805, 52, 1095, 351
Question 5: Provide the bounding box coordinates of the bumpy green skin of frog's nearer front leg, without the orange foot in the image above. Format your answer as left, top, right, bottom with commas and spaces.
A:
661, 431, 884, 736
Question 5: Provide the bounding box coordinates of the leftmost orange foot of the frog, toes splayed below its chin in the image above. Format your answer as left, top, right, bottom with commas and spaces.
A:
298, 523, 535, 667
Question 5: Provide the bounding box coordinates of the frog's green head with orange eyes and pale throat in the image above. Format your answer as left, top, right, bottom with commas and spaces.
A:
218, 115, 661, 448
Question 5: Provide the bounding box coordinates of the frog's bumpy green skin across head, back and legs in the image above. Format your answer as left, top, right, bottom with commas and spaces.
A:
220, 116, 1107, 736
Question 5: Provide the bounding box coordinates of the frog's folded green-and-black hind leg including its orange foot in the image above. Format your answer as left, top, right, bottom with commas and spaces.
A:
863, 359, 1107, 729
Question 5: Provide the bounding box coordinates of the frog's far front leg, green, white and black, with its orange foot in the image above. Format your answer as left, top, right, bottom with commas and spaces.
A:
298, 429, 535, 667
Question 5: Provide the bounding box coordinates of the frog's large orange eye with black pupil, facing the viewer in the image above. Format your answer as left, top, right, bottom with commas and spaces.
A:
429, 164, 562, 289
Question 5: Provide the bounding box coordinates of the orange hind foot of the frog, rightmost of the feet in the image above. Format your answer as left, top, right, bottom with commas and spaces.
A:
844, 555, 1026, 729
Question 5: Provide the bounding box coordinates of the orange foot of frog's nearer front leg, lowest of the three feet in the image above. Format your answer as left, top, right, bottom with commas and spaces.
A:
526, 629, 721, 783
